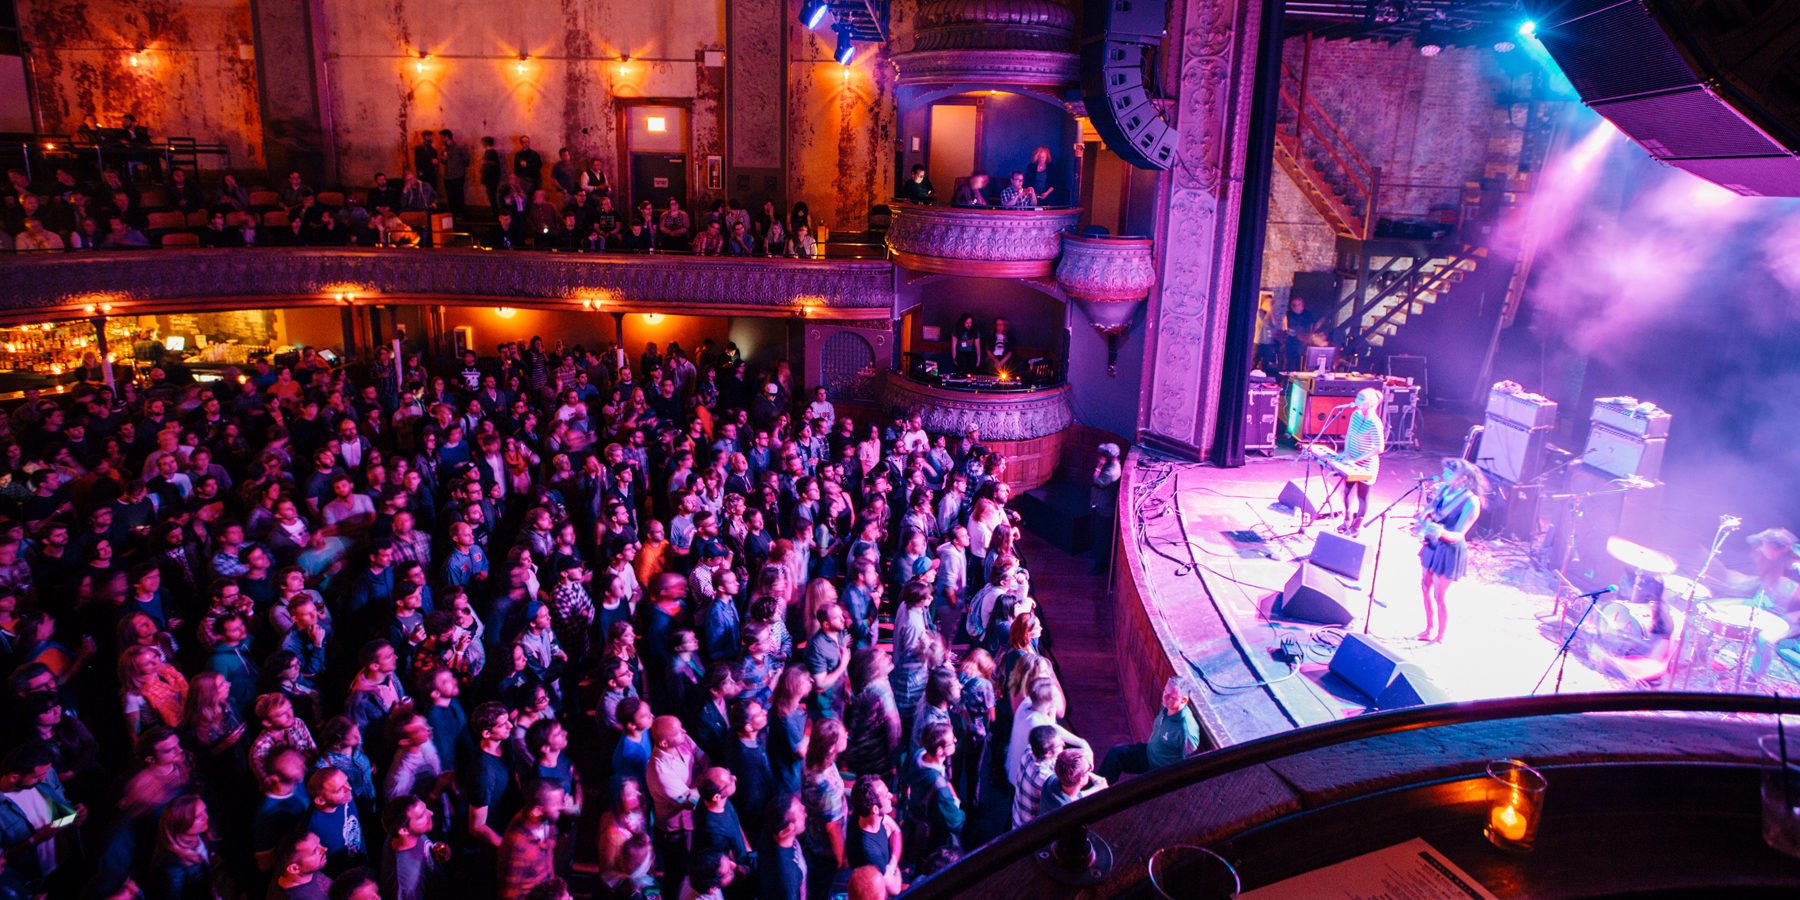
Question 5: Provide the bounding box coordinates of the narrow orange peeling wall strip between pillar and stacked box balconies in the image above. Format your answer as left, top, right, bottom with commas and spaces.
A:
787, 0, 918, 230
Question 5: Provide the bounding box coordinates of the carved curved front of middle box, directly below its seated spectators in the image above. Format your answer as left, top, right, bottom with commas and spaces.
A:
887, 203, 1082, 277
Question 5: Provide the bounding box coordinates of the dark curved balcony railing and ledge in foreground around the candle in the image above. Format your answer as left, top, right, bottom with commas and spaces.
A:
907, 693, 1800, 900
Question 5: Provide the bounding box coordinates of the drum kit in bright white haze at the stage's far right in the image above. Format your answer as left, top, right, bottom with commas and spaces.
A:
1562, 535, 1789, 691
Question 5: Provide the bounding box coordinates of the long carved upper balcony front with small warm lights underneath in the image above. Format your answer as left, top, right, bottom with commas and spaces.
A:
0, 248, 893, 319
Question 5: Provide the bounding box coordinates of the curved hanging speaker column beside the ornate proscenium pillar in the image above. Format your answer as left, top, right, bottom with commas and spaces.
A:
1082, 0, 1175, 169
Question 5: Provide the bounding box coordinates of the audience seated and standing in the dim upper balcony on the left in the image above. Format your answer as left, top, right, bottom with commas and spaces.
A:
0, 130, 821, 259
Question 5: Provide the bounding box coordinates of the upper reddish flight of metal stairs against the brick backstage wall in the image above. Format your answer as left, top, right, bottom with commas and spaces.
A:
1274, 65, 1381, 238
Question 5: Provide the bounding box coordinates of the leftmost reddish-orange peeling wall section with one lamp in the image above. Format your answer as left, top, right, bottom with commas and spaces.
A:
18, 0, 263, 169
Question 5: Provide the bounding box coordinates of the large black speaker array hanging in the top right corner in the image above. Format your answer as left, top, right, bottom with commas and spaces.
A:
1537, 0, 1800, 196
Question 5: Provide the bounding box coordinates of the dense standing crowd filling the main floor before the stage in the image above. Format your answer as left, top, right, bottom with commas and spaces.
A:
0, 331, 1199, 900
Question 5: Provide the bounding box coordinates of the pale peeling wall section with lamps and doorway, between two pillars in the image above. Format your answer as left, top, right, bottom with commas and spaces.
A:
322, 0, 725, 191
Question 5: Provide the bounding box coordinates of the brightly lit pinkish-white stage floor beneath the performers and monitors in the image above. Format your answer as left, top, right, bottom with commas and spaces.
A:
1114, 441, 1795, 745
